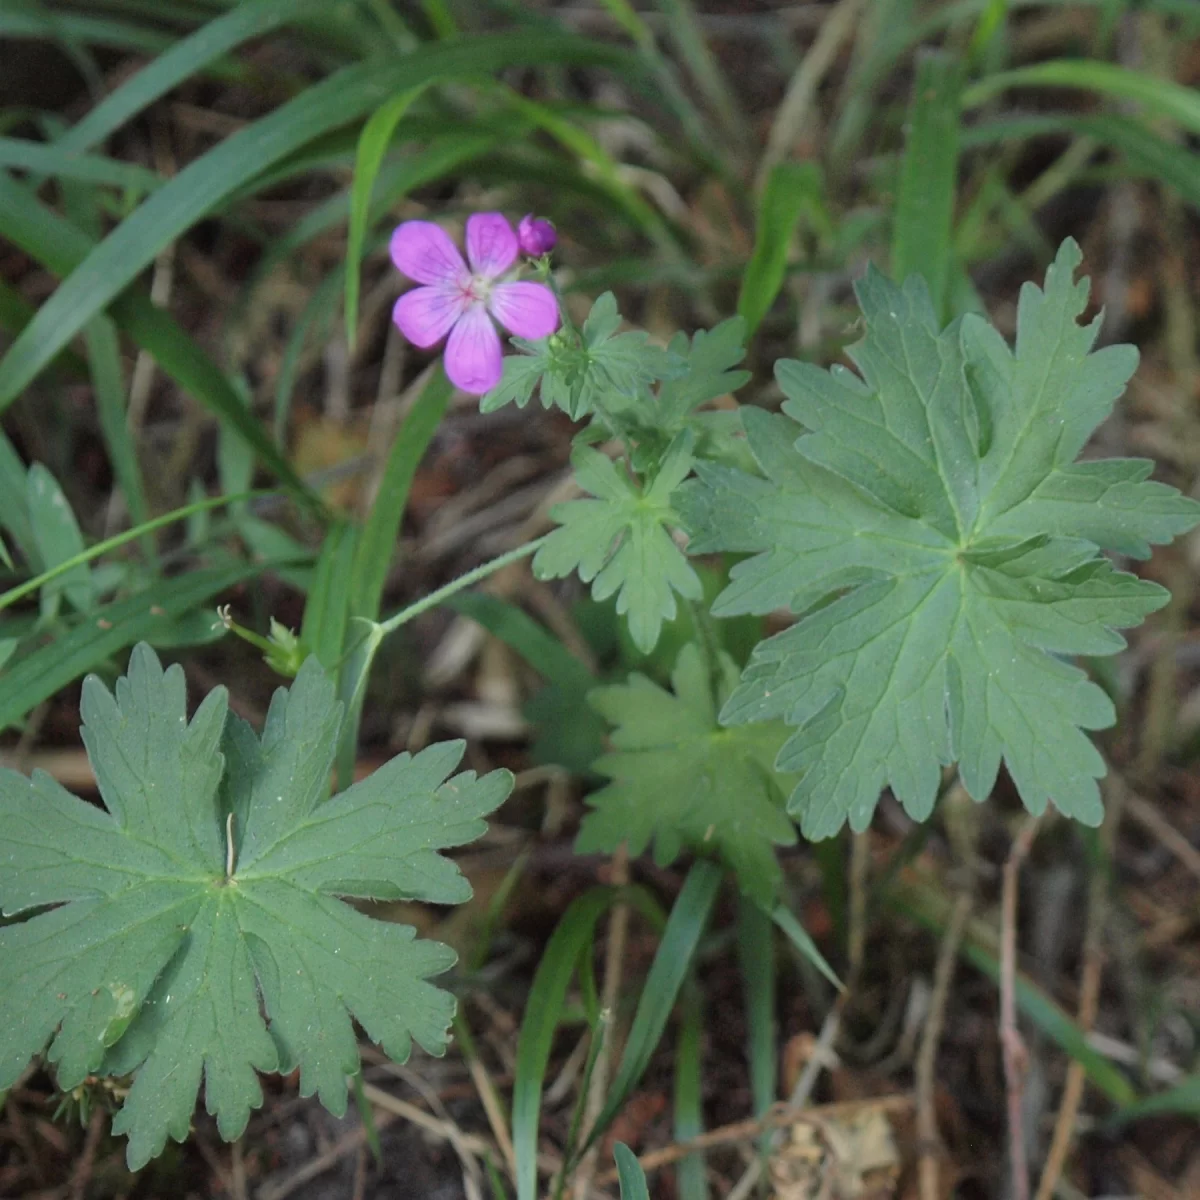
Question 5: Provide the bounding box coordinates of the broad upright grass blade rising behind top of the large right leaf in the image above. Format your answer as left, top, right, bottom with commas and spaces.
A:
892, 54, 962, 320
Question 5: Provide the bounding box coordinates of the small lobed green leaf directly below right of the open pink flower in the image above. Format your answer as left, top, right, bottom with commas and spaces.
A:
480, 292, 681, 421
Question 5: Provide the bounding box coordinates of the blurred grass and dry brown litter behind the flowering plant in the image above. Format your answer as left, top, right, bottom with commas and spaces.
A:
0, 0, 1200, 1200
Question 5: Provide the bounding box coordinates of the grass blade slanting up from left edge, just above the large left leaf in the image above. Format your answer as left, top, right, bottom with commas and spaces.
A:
0, 563, 264, 730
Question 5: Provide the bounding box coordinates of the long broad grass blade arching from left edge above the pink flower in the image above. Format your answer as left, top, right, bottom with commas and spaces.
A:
0, 34, 636, 410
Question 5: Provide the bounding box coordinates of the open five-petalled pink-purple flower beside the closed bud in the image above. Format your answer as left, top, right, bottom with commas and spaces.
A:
391, 212, 558, 396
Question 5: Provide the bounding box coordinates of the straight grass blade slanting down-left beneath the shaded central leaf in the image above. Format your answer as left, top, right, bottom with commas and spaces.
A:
587, 859, 724, 1145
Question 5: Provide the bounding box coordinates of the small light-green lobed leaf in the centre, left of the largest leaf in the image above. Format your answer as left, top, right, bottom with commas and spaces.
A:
533, 432, 702, 654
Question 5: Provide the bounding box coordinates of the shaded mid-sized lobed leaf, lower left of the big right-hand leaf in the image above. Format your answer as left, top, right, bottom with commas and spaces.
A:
575, 642, 796, 908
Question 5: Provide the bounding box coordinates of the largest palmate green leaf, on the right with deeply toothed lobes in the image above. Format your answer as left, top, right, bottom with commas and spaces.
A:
680, 241, 1200, 839
